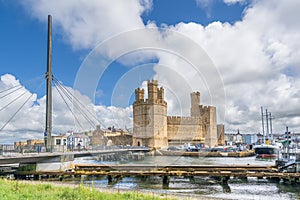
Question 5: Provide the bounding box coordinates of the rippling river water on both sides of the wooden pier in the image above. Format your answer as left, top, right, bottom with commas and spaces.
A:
77, 156, 300, 200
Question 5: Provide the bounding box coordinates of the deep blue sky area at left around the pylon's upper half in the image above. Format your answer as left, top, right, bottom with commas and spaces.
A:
0, 1, 81, 96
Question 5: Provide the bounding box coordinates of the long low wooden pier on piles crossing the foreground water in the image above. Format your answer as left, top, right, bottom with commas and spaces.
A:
9, 164, 300, 188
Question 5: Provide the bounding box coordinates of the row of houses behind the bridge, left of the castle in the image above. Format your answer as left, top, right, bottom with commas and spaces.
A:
14, 125, 132, 153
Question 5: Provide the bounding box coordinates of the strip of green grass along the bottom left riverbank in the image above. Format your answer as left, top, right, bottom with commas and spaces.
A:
0, 179, 173, 200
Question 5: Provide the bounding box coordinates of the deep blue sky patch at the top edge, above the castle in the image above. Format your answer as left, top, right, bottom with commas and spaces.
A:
142, 0, 248, 25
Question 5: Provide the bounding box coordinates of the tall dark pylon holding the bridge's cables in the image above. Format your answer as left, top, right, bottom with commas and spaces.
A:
44, 15, 53, 151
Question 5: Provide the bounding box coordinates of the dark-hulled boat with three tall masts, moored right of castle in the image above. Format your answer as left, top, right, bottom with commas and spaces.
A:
253, 107, 279, 159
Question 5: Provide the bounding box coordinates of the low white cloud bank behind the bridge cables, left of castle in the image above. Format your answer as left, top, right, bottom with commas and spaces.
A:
0, 74, 132, 143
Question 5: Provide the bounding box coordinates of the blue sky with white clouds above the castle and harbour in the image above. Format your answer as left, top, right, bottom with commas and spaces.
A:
0, 0, 300, 143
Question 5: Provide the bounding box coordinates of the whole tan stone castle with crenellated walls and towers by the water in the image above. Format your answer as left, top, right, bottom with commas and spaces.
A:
133, 80, 225, 148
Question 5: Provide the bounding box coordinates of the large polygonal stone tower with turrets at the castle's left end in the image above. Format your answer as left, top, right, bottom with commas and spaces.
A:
133, 80, 168, 148
